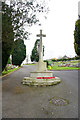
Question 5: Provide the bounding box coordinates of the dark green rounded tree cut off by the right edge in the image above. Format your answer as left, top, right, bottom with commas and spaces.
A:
74, 18, 80, 56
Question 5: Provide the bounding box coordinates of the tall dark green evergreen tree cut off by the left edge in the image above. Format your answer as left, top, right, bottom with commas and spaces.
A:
2, 2, 14, 70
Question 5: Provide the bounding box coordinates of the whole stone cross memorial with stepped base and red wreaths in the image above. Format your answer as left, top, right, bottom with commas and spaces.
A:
23, 30, 61, 86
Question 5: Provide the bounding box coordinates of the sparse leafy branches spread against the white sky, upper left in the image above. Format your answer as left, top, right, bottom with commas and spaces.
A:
10, 0, 49, 39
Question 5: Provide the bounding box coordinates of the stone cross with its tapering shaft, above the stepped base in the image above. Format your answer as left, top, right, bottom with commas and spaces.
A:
37, 30, 46, 61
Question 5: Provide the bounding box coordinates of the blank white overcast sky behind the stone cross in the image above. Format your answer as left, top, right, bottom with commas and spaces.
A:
25, 0, 79, 61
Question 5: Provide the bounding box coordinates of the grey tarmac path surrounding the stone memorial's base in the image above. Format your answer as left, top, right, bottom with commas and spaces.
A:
2, 65, 78, 118
